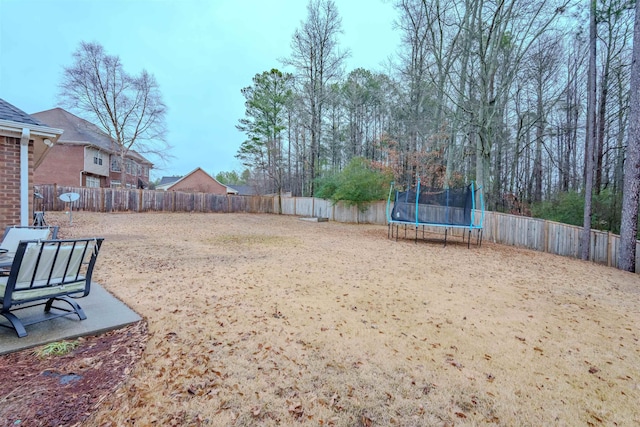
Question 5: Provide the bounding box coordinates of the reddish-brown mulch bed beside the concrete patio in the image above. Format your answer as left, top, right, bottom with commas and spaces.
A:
0, 321, 148, 426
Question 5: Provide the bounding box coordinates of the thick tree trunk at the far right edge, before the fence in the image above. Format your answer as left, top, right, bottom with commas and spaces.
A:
618, 2, 640, 271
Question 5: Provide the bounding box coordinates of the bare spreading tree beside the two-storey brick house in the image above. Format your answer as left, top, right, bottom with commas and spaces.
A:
59, 42, 170, 186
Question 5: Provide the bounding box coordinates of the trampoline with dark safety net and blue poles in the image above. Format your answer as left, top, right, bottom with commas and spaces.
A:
386, 180, 484, 247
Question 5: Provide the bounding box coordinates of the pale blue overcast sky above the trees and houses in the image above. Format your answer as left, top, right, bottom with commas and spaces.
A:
0, 0, 399, 179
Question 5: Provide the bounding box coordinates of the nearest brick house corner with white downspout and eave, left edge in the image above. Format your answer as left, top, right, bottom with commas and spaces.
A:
0, 99, 62, 230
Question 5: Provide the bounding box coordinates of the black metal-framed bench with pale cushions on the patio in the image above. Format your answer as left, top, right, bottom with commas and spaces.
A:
0, 238, 104, 337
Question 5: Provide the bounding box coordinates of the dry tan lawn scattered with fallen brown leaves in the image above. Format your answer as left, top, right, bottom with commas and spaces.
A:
47, 212, 640, 426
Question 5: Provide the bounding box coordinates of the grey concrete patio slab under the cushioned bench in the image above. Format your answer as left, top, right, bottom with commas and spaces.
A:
0, 283, 141, 355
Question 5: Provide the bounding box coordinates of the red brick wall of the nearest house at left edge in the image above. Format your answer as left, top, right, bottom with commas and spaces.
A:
0, 136, 33, 230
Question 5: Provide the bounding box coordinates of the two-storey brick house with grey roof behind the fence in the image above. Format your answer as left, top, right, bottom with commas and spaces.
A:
32, 108, 153, 188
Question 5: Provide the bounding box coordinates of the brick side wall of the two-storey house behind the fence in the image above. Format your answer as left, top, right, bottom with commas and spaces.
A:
33, 144, 84, 187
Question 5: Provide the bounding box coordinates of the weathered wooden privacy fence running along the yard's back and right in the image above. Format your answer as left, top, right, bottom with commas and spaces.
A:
39, 185, 640, 273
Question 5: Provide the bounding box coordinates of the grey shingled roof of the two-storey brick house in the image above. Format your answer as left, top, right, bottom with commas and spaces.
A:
32, 107, 152, 165
